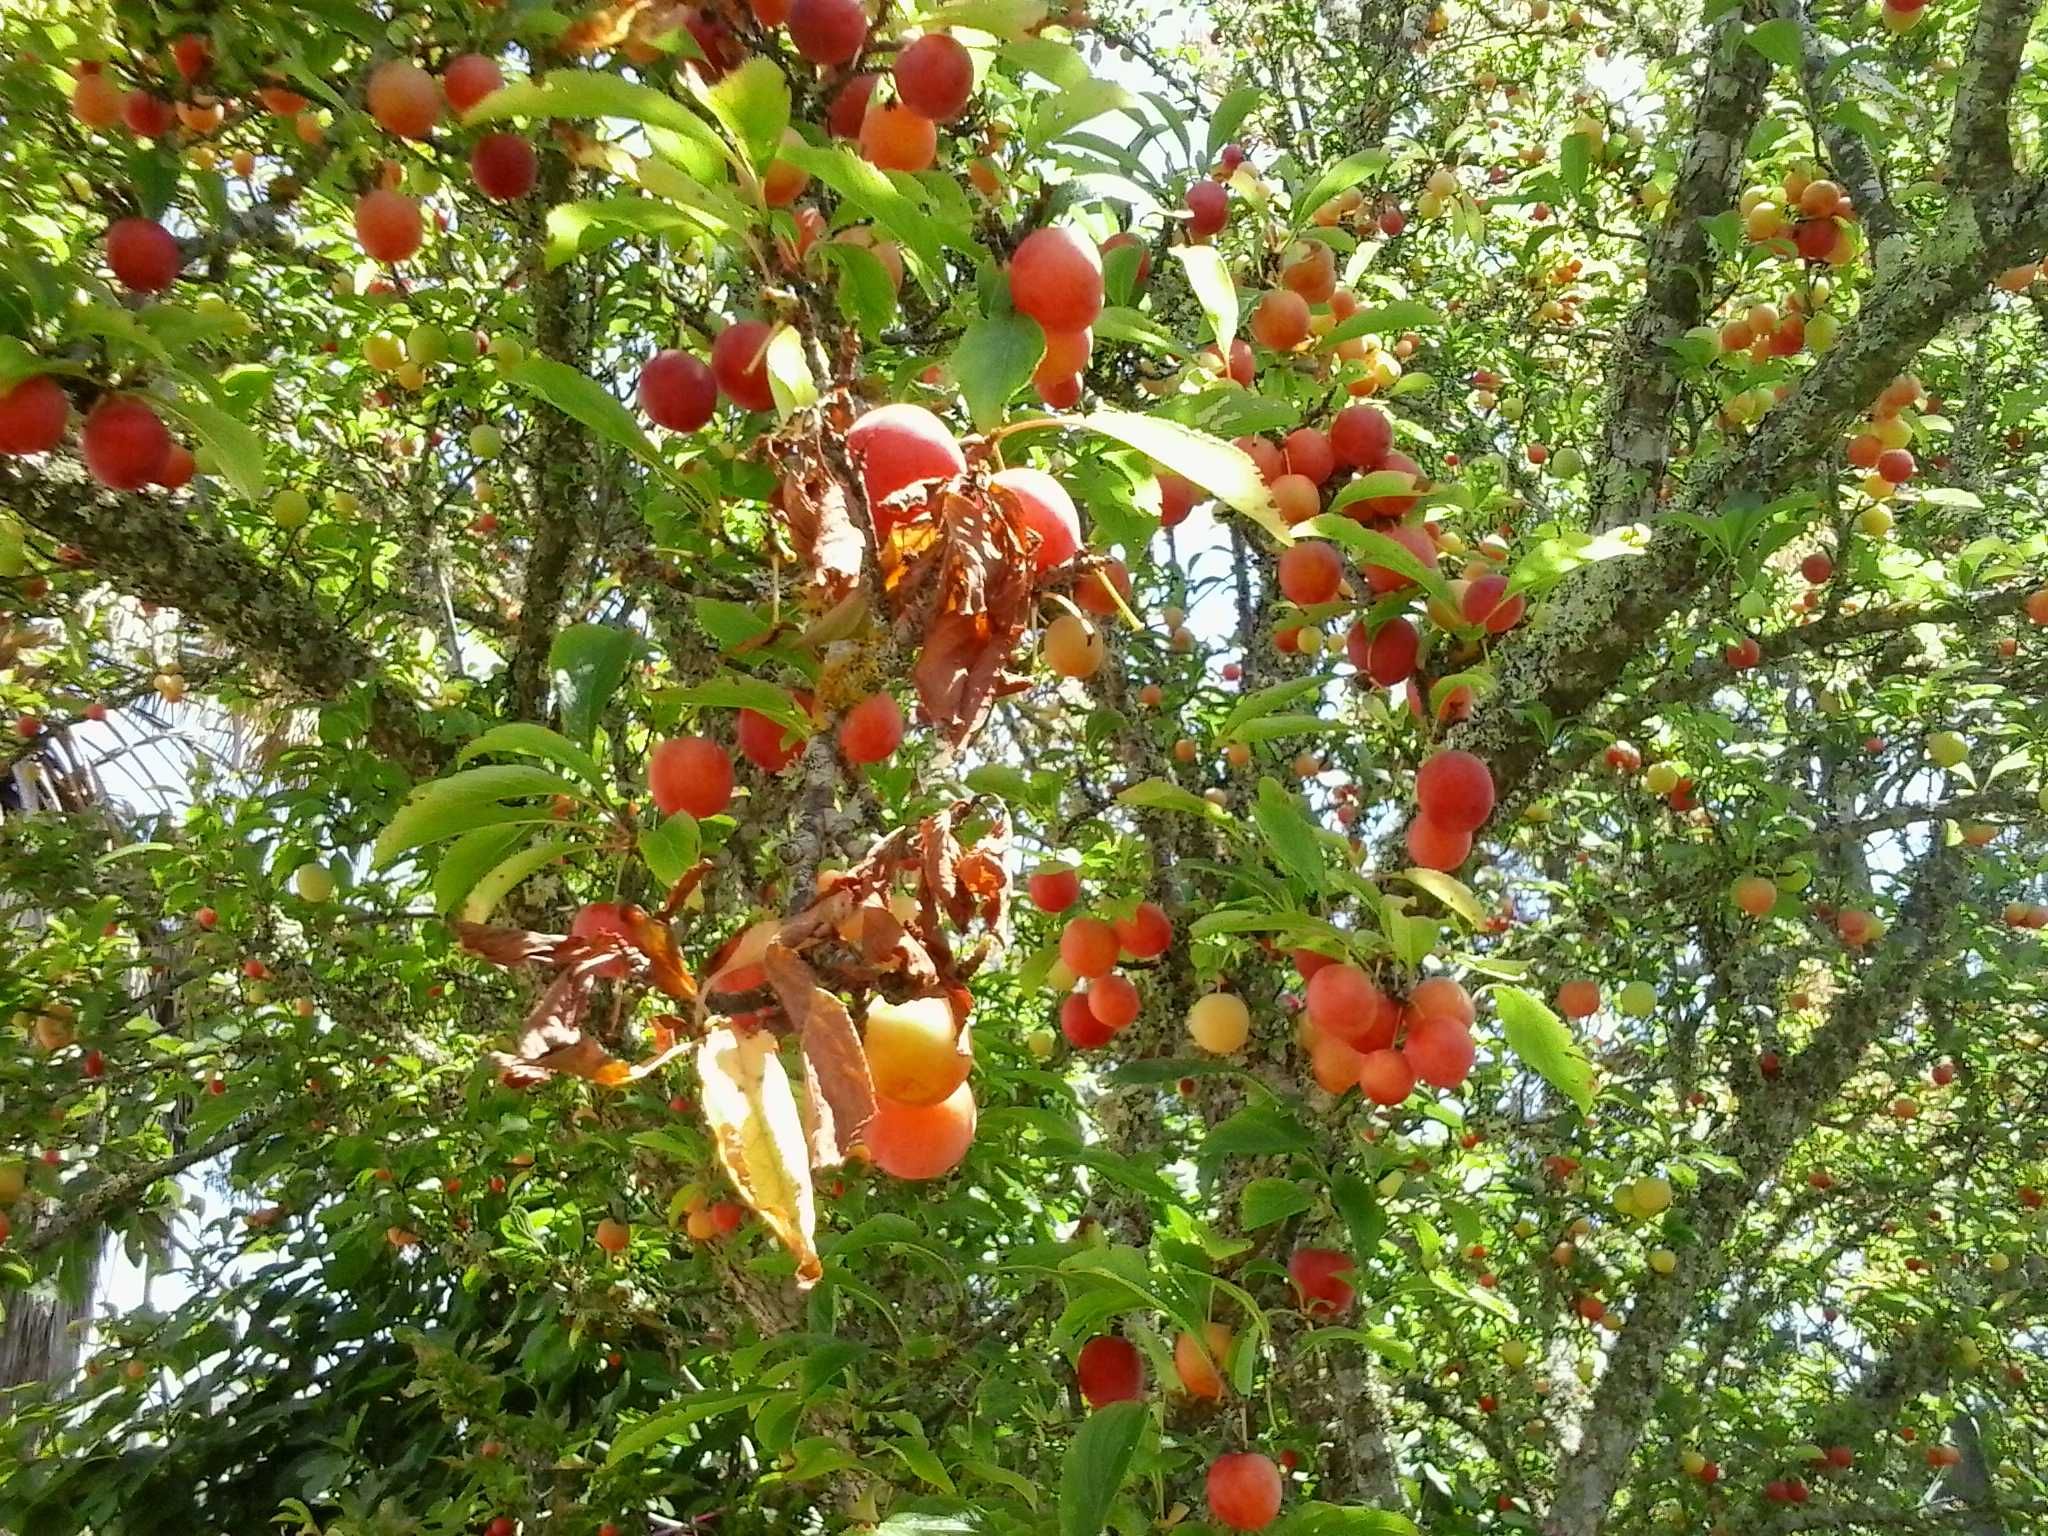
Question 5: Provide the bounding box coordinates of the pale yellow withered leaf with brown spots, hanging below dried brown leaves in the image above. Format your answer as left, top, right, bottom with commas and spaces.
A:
696, 1026, 825, 1288
